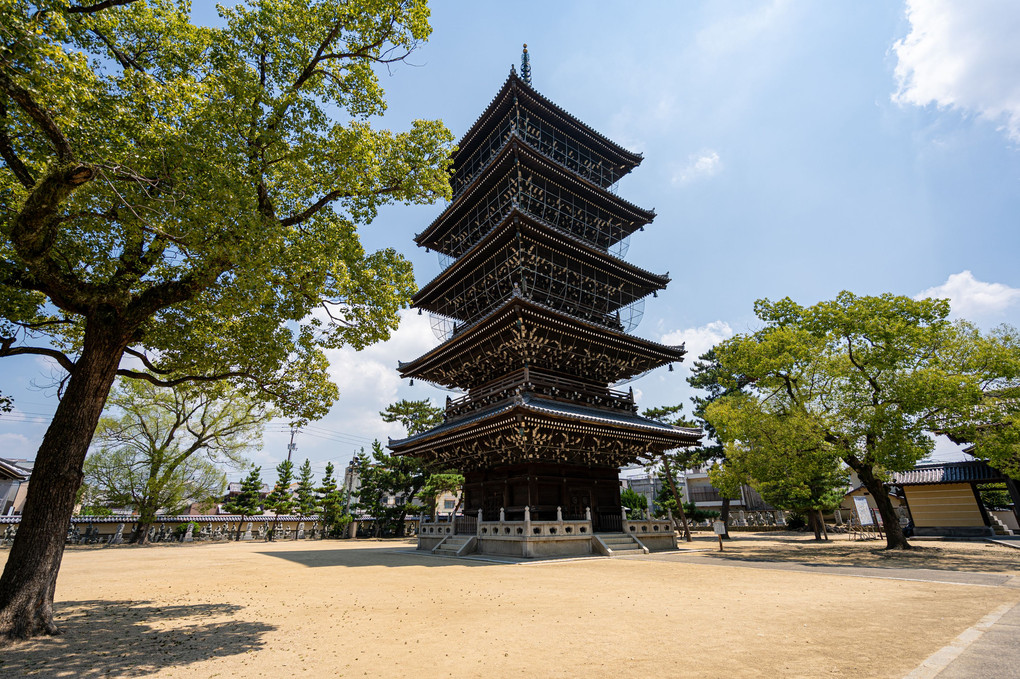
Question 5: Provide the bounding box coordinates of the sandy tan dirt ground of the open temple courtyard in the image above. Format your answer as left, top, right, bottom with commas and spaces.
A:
0, 534, 1020, 679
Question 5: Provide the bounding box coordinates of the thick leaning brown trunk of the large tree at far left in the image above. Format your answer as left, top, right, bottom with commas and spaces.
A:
0, 321, 128, 640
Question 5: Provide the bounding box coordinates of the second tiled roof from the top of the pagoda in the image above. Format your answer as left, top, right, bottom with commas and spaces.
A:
414, 135, 655, 250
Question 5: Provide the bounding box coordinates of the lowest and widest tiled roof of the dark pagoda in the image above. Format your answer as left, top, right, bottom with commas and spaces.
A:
389, 394, 703, 454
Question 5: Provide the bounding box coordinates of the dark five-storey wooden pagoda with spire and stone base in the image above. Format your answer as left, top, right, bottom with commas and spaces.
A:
390, 46, 701, 556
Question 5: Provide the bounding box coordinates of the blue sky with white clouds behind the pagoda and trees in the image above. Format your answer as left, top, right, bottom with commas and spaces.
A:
0, 0, 1020, 470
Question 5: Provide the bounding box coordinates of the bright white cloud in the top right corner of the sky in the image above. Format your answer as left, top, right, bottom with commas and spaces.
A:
893, 0, 1020, 142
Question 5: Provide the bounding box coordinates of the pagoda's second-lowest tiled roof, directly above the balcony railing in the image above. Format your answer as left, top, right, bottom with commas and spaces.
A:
398, 291, 686, 381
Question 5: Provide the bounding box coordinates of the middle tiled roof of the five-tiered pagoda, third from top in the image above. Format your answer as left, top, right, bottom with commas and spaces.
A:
411, 207, 669, 314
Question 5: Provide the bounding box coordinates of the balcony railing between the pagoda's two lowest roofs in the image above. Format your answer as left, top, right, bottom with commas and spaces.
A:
446, 368, 638, 421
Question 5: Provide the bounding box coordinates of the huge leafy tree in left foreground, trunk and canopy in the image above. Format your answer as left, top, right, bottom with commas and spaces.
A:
0, 0, 452, 638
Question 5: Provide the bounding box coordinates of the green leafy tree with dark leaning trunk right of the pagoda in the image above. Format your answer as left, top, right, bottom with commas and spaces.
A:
706, 292, 1017, 549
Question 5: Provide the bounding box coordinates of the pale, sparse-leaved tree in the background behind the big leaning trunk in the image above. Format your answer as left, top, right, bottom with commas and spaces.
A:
84, 380, 271, 543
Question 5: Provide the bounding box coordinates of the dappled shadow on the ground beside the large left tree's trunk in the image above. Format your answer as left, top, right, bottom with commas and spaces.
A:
0, 600, 276, 677
